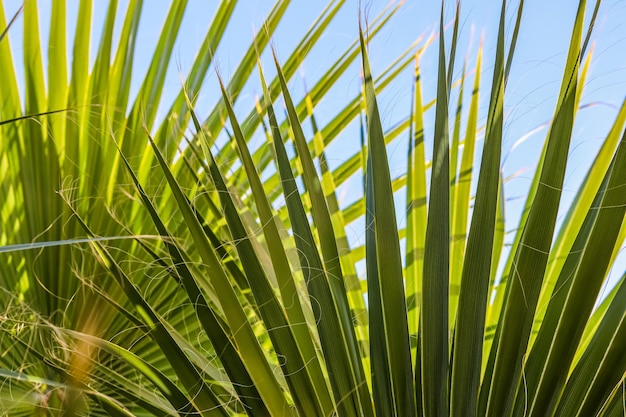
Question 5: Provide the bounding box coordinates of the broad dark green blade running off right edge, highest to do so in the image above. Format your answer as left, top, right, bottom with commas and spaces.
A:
516, 109, 626, 415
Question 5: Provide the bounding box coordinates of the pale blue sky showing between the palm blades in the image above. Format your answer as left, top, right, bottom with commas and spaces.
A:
4, 0, 626, 290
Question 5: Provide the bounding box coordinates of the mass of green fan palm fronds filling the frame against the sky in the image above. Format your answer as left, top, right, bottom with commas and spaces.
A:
0, 0, 626, 417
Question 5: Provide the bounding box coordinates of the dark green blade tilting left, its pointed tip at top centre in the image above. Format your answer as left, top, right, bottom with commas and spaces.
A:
361, 26, 415, 415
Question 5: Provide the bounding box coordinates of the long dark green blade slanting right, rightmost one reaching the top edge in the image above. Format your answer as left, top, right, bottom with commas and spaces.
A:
483, 1, 585, 416
